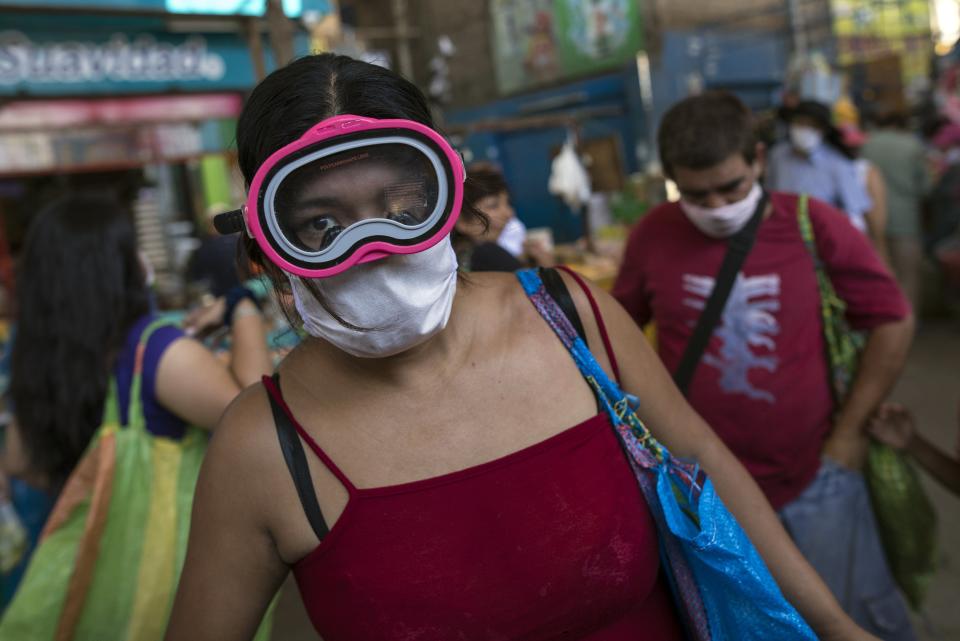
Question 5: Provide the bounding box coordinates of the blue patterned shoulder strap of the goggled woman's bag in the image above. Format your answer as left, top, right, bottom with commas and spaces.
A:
516, 269, 670, 467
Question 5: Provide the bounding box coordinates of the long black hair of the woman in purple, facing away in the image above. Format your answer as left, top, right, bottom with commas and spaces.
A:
10, 194, 150, 485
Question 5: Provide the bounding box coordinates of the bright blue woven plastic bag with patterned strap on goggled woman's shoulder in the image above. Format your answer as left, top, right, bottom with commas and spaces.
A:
517, 270, 817, 641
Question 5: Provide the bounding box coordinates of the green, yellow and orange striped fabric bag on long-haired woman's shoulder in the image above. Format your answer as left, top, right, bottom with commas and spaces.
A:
0, 321, 271, 641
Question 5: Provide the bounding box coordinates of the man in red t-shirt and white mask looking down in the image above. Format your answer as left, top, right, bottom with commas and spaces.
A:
613, 93, 915, 640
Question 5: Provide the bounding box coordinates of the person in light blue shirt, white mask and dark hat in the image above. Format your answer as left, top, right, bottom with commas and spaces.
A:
766, 100, 873, 231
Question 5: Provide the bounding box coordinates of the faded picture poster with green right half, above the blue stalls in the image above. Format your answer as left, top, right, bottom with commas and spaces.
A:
490, 0, 643, 93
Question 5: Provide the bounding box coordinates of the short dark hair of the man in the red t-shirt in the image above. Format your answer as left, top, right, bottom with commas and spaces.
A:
657, 91, 757, 176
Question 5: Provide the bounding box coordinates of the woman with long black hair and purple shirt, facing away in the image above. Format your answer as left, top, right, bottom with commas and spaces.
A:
6, 195, 271, 488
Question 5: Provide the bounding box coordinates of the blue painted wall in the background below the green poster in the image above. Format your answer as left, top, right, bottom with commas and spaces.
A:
447, 31, 788, 242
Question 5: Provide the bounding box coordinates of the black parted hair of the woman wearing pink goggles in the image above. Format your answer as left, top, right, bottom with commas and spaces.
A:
237, 53, 488, 322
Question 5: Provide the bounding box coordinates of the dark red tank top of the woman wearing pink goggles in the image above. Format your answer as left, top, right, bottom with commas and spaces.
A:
264, 274, 682, 641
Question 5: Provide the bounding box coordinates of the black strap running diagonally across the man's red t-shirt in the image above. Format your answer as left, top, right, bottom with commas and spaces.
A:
673, 190, 770, 396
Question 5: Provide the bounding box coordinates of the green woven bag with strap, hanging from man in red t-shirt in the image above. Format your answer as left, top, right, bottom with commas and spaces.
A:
797, 196, 937, 610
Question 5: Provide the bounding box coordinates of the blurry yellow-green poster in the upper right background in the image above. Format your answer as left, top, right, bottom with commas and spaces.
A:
832, 0, 932, 93
